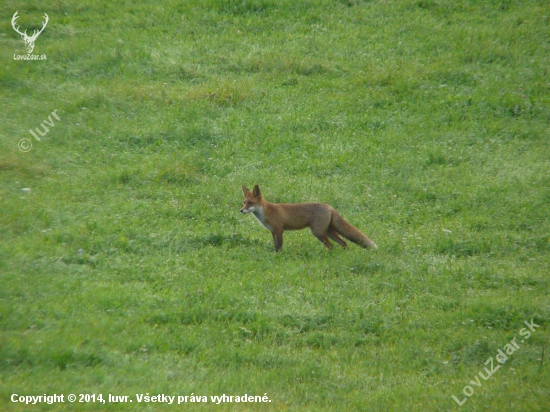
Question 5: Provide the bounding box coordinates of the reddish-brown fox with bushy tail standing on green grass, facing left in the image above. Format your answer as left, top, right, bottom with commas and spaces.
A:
241, 185, 377, 252
